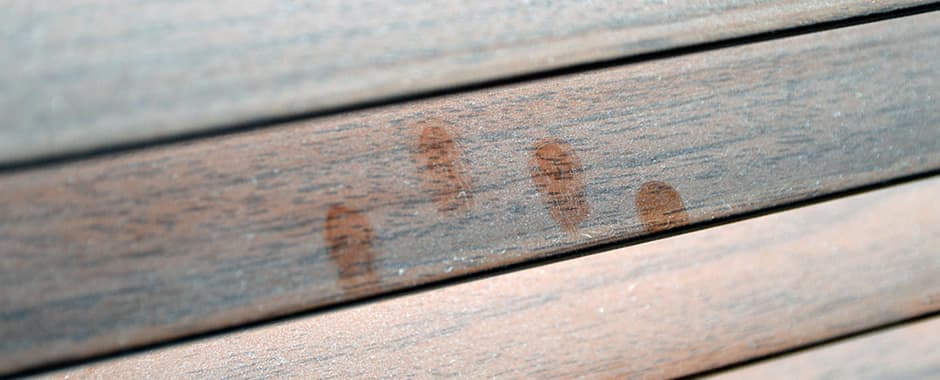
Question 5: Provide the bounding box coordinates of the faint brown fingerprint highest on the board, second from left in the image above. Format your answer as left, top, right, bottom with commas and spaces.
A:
415, 119, 473, 213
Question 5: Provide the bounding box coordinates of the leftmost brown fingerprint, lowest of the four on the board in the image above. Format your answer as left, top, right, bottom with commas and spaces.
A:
324, 206, 378, 293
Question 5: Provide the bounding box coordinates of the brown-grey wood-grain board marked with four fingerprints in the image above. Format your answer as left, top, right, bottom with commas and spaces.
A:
0, 13, 940, 370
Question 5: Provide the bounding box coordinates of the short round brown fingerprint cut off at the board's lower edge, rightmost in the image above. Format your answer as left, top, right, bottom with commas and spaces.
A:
636, 181, 689, 232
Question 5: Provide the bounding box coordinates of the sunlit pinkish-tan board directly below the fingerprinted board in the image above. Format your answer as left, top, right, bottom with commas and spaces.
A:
36, 177, 940, 379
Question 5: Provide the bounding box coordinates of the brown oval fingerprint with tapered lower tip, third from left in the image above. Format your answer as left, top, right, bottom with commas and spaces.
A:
529, 138, 590, 232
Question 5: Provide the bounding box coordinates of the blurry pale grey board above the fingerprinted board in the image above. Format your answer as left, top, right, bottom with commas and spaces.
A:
0, 0, 928, 163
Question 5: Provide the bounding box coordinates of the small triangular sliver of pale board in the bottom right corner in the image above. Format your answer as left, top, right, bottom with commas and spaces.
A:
708, 317, 940, 380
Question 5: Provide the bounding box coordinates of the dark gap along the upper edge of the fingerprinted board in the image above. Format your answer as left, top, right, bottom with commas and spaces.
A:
0, 2, 940, 174
